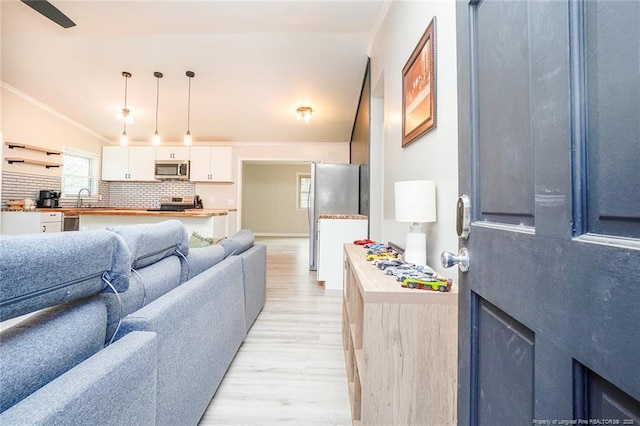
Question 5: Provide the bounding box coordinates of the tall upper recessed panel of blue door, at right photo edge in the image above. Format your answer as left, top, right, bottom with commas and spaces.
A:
583, 1, 640, 238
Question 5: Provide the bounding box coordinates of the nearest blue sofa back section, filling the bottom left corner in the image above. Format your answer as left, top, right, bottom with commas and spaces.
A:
0, 332, 157, 426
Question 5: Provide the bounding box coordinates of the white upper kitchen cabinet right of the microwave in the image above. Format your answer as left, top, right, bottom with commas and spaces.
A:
189, 146, 233, 182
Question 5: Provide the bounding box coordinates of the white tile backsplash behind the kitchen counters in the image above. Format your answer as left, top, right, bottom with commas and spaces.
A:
1, 171, 196, 208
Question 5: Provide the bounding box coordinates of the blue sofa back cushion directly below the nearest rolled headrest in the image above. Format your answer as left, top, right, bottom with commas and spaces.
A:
0, 295, 107, 411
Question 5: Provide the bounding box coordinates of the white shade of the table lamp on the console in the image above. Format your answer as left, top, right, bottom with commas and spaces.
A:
395, 180, 436, 223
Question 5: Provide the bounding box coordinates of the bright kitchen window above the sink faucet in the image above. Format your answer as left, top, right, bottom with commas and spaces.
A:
62, 148, 98, 197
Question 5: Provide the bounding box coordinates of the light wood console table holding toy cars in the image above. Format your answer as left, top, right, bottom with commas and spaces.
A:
342, 244, 458, 426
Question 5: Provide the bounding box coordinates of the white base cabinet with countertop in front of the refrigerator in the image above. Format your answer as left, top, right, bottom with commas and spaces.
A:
318, 214, 369, 290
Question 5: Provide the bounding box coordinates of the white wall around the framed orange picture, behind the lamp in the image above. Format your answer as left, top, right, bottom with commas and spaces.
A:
371, 0, 458, 278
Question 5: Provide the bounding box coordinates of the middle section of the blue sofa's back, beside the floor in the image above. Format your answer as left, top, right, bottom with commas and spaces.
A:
118, 256, 246, 425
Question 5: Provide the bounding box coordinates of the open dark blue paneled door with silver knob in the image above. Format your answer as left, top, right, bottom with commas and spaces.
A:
457, 0, 640, 425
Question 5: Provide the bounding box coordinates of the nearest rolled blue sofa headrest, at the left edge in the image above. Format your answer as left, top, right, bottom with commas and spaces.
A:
0, 230, 131, 321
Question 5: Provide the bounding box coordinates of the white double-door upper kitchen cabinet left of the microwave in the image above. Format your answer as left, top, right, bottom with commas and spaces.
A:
102, 146, 156, 182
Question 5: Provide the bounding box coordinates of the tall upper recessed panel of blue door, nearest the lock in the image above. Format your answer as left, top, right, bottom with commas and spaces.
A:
474, 1, 534, 225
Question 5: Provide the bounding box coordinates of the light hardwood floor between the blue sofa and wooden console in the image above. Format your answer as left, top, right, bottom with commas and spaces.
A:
200, 238, 351, 426
